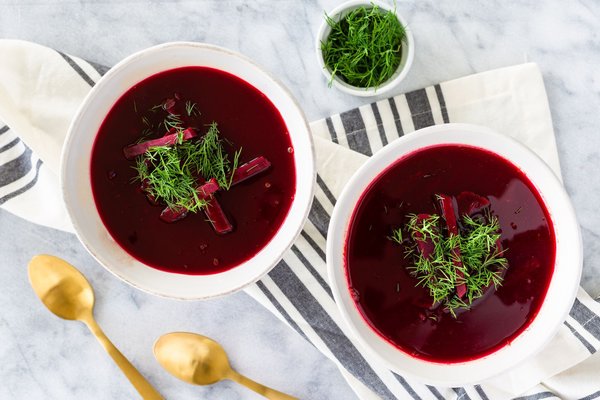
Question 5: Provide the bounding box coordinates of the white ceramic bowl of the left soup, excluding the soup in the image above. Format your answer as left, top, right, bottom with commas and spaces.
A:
61, 42, 316, 299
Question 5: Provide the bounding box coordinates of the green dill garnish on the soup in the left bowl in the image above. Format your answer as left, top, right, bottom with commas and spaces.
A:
133, 94, 241, 216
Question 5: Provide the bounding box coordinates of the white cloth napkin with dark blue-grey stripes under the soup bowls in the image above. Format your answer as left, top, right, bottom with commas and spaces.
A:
0, 40, 600, 400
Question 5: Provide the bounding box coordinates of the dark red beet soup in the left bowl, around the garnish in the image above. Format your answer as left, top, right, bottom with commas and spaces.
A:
90, 67, 296, 275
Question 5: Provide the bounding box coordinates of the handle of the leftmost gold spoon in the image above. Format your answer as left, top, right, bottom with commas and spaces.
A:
83, 315, 164, 400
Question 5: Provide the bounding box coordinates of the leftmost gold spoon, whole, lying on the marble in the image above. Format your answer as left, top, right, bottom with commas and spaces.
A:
28, 255, 163, 400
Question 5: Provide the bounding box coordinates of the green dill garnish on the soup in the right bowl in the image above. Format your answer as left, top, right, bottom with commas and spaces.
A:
391, 209, 508, 317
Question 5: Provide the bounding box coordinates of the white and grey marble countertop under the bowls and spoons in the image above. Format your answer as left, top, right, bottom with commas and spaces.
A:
0, 0, 600, 400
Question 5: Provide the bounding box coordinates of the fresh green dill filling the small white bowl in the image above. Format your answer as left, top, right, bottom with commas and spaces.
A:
321, 4, 406, 88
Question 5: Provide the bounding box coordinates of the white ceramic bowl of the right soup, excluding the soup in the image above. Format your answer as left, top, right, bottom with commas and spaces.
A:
327, 124, 583, 387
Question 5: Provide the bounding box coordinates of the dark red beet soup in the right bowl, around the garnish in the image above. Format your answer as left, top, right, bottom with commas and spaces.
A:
345, 145, 556, 363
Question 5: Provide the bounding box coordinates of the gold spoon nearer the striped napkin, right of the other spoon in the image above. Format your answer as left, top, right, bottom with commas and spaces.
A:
154, 332, 297, 400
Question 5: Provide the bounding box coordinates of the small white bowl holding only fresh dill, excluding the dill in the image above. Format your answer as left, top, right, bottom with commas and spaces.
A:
315, 0, 415, 97
